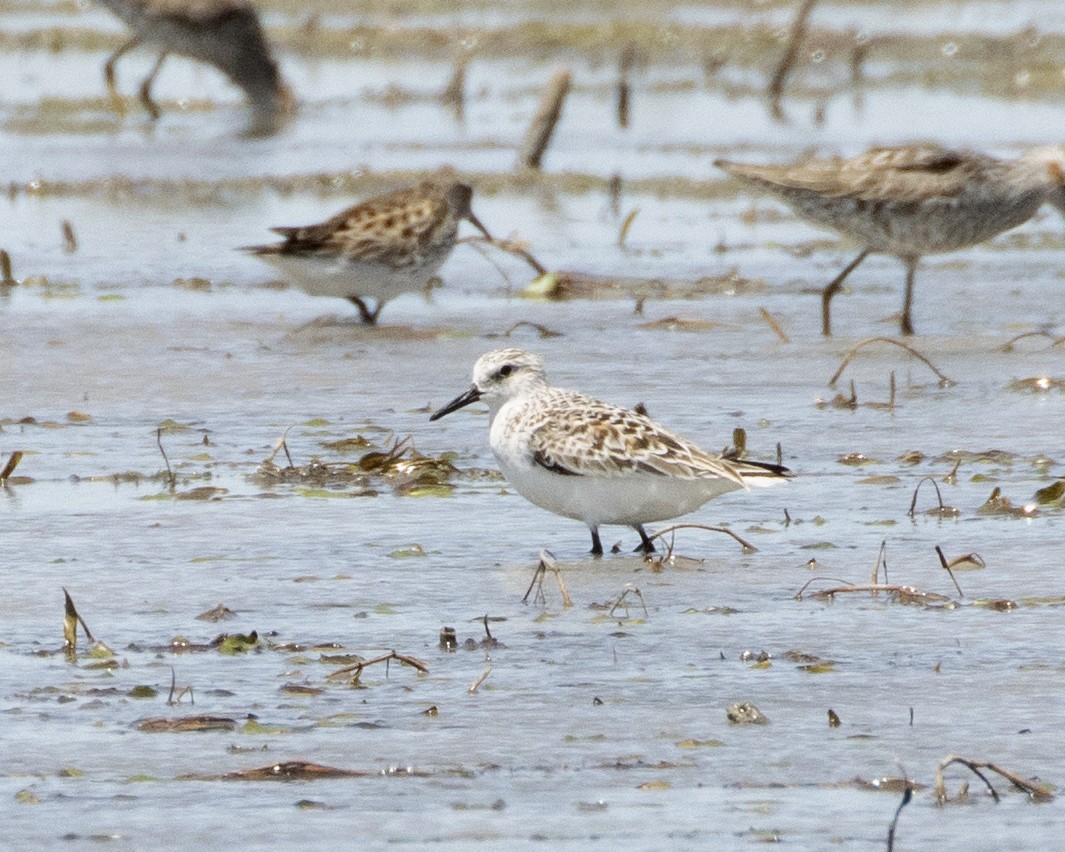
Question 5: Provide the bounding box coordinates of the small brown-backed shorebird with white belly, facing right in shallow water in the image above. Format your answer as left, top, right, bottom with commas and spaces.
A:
243, 180, 492, 325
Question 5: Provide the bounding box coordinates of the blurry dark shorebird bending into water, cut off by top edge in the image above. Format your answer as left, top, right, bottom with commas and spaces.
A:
97, 0, 295, 135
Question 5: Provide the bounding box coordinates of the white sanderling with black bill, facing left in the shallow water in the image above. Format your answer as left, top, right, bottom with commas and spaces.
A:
429, 349, 790, 555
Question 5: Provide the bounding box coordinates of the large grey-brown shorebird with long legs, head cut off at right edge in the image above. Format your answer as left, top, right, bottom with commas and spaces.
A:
715, 144, 1065, 335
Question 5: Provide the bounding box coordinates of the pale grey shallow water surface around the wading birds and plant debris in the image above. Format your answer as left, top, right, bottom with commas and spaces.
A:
0, 0, 1065, 850
